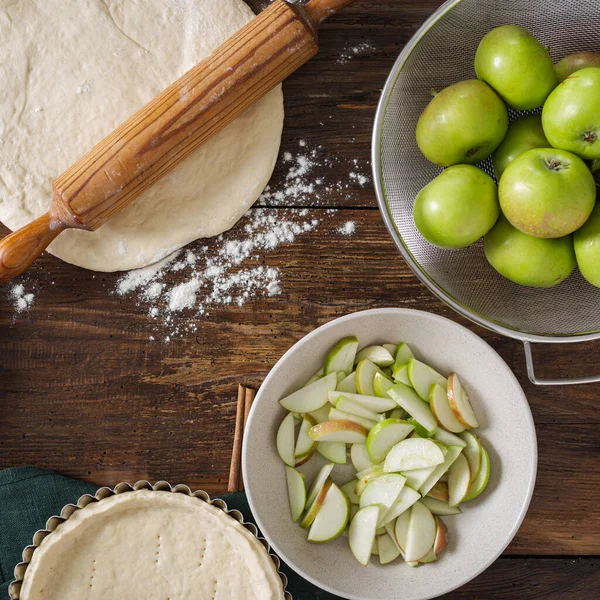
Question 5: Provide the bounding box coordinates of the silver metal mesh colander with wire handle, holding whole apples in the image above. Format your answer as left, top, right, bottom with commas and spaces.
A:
373, 0, 600, 384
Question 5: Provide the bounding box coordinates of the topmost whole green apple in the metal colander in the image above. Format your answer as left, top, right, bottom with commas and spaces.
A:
475, 25, 558, 110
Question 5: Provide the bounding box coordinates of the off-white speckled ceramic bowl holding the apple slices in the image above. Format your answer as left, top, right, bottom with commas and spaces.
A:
243, 308, 537, 600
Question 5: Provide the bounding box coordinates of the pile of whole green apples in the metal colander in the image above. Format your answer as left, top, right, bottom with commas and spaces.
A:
413, 25, 600, 288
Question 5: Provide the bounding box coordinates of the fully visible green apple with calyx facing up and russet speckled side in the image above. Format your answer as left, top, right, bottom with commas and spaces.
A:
498, 147, 600, 238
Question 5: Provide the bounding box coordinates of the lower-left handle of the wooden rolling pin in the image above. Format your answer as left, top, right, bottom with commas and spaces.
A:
0, 212, 65, 283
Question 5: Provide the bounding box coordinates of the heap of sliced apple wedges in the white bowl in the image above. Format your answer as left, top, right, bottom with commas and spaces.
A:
277, 337, 490, 567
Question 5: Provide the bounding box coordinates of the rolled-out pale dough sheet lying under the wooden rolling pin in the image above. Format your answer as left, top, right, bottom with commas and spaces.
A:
0, 0, 283, 271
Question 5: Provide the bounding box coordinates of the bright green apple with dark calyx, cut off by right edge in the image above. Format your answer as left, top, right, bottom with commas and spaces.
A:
542, 67, 600, 160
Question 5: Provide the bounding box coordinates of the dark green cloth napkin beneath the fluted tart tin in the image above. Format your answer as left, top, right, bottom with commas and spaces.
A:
0, 467, 337, 600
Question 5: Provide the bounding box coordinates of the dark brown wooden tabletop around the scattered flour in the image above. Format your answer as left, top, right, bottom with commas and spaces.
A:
0, 0, 600, 600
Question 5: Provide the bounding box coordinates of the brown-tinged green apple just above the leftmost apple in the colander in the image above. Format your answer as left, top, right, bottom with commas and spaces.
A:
417, 79, 508, 167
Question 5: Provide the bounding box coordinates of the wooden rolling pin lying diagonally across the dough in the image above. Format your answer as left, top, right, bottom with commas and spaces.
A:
0, 0, 354, 282
